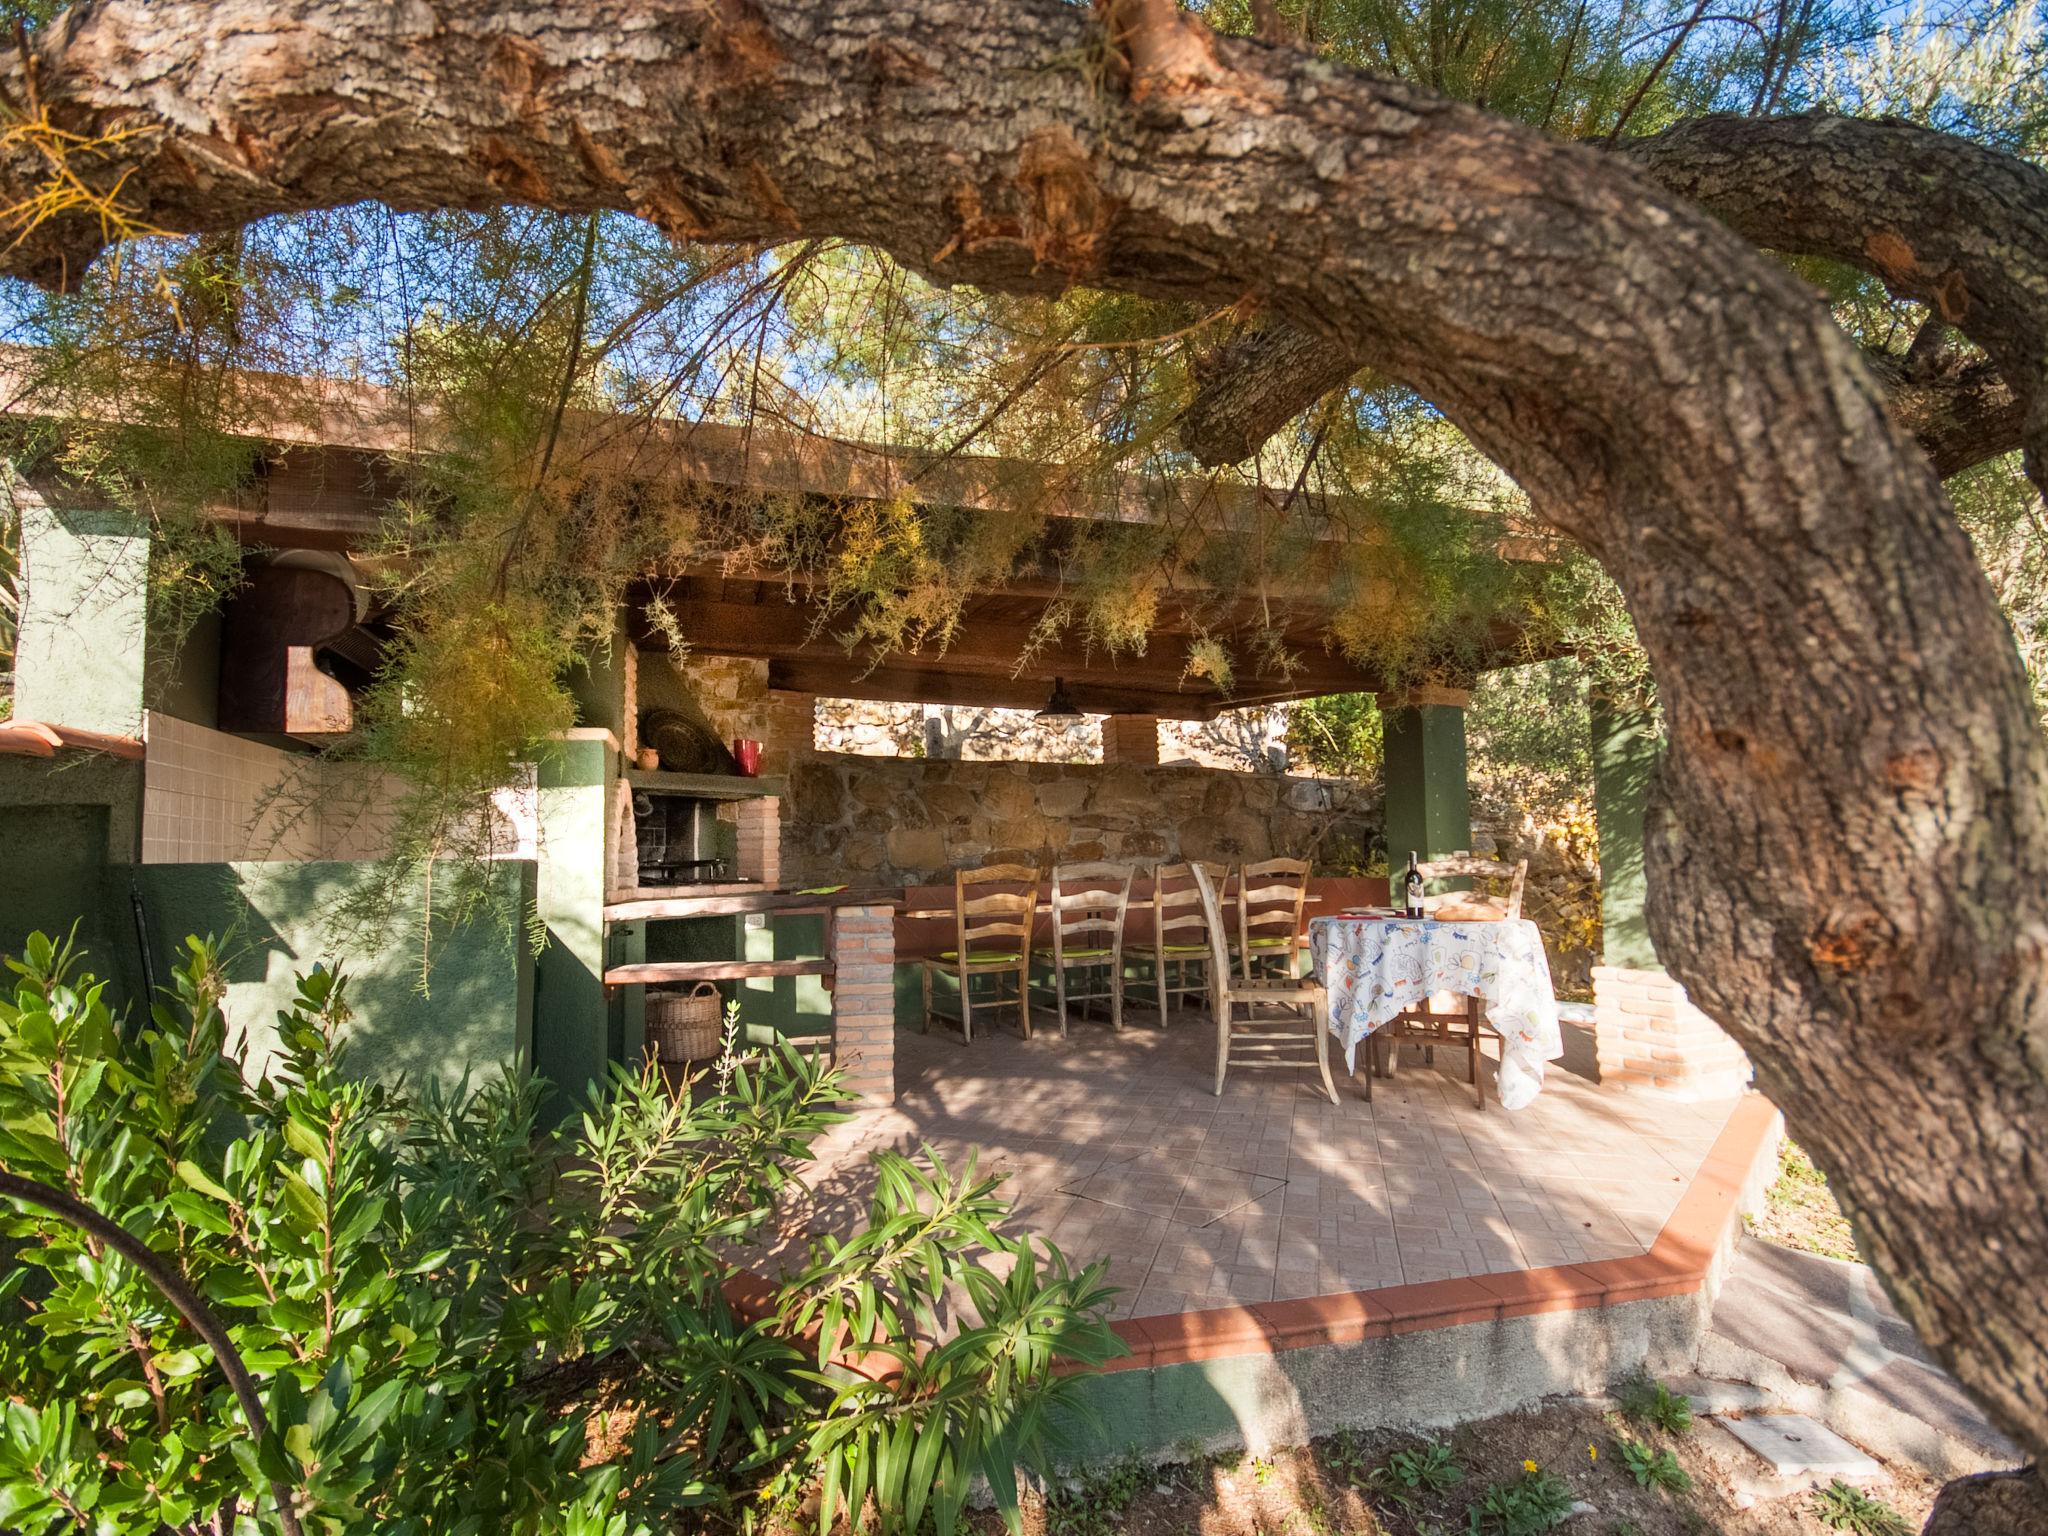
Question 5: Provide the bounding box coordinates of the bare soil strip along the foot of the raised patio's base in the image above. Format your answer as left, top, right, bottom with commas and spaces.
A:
985, 1399, 1939, 1536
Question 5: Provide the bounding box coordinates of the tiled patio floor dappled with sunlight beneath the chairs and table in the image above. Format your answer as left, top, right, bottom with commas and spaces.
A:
782, 1014, 1735, 1317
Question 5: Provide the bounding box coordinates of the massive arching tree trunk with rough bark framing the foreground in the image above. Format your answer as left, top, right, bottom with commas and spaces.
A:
0, 0, 2048, 1482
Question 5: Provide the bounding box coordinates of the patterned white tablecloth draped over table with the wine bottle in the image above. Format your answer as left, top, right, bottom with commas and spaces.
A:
1309, 918, 1565, 1110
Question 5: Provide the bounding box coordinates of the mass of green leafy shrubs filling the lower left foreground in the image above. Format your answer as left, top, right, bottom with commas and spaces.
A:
0, 934, 1118, 1536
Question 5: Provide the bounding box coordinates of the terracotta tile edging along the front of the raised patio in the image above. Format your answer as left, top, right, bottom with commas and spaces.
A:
1098, 1094, 1778, 1372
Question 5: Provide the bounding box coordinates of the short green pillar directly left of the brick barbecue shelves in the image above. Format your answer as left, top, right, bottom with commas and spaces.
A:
532, 727, 627, 1110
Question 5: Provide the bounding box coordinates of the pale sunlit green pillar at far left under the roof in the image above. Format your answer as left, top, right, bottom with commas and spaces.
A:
14, 481, 150, 735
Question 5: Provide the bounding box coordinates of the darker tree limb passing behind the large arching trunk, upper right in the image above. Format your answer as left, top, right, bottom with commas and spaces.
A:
1180, 113, 2048, 494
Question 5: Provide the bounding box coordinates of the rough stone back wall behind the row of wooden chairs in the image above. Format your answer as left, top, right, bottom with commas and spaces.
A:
782, 754, 1380, 885
